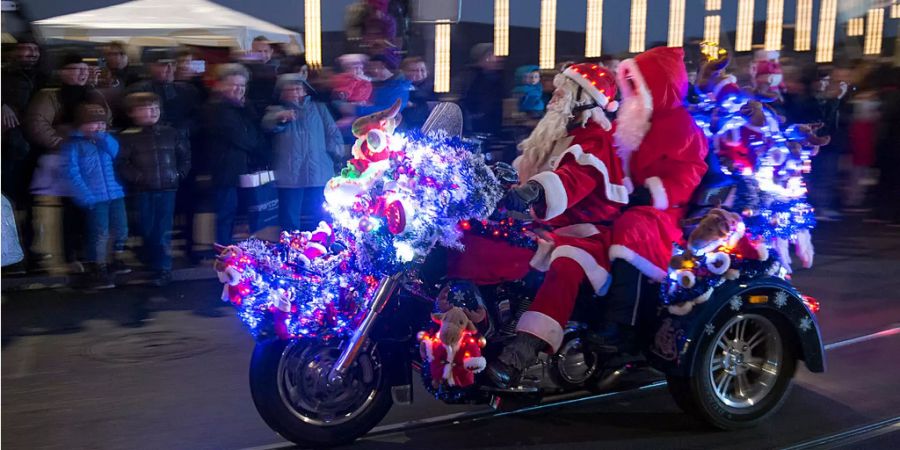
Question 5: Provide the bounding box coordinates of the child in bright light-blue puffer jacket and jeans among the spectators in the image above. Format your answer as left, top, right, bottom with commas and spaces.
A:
61, 103, 128, 289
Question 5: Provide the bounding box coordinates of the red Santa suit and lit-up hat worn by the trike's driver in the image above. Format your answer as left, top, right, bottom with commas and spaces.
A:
516, 64, 628, 351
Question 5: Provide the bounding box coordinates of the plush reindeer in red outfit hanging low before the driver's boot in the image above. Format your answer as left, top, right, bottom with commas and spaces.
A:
420, 307, 486, 388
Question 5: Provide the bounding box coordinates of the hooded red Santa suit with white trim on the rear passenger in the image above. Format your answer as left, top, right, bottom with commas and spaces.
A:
609, 47, 707, 280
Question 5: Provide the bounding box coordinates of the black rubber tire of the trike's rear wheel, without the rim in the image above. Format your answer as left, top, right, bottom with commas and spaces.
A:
667, 311, 797, 430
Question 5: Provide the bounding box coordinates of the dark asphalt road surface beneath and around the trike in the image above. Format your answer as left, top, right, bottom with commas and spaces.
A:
2, 217, 900, 450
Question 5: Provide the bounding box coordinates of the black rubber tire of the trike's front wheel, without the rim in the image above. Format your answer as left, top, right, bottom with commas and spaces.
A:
250, 340, 393, 448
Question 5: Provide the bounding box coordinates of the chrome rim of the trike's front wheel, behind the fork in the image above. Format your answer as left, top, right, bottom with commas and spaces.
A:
277, 341, 381, 426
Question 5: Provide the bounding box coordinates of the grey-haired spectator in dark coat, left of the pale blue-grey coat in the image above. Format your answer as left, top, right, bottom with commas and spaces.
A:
204, 64, 268, 245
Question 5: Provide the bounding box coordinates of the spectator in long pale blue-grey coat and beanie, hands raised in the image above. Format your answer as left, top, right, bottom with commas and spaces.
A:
262, 74, 346, 231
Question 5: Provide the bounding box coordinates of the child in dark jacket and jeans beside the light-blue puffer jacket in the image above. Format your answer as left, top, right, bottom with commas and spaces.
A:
118, 92, 191, 286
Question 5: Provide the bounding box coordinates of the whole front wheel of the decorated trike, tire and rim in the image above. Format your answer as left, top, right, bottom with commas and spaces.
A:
250, 340, 392, 447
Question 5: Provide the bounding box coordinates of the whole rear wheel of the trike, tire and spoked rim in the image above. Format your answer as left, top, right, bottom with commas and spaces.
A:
668, 312, 796, 430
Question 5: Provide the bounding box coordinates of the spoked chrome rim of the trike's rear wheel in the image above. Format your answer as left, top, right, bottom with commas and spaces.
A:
708, 314, 784, 409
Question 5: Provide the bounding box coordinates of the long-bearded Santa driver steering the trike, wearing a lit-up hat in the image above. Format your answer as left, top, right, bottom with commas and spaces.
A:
488, 64, 628, 387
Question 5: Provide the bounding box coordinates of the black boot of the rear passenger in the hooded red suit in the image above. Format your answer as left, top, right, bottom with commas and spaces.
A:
590, 259, 647, 353
